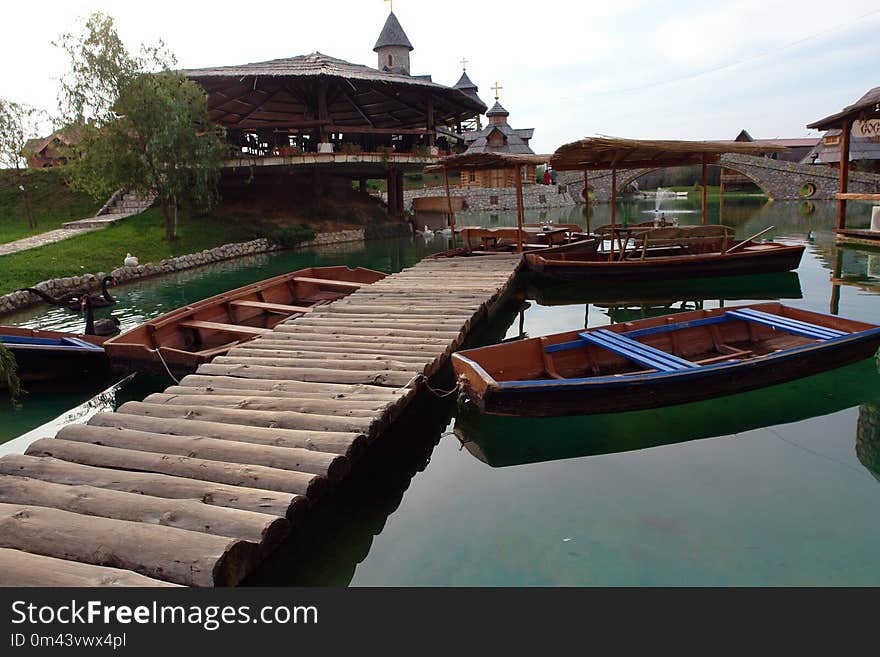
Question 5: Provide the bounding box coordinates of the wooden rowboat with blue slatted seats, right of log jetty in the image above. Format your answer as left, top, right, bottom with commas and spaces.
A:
452, 303, 880, 416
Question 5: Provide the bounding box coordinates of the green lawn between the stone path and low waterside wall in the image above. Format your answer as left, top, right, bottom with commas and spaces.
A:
0, 209, 255, 294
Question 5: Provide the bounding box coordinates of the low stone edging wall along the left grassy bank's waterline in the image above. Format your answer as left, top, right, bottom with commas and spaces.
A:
0, 228, 364, 315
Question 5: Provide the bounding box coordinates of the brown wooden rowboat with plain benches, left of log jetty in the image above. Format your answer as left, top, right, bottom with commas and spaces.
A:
104, 266, 385, 375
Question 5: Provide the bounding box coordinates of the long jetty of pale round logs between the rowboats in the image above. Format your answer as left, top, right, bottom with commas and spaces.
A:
0, 254, 521, 586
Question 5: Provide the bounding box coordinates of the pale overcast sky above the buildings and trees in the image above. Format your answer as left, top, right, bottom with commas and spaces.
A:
0, 0, 880, 152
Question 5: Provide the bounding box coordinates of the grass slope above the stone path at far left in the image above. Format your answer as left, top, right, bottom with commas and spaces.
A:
0, 169, 103, 244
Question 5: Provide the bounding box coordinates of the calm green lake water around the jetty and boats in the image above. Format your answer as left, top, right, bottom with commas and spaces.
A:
0, 198, 880, 586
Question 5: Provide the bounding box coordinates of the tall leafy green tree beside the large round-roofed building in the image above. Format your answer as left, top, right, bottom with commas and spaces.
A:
59, 13, 225, 240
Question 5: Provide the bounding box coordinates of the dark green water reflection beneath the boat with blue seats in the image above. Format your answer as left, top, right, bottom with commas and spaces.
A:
455, 360, 880, 466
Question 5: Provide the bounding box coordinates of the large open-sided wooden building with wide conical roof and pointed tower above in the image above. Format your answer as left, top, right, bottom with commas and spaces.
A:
184, 13, 486, 214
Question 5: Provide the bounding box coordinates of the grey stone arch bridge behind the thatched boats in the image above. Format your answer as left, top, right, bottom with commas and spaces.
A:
559, 153, 880, 202
